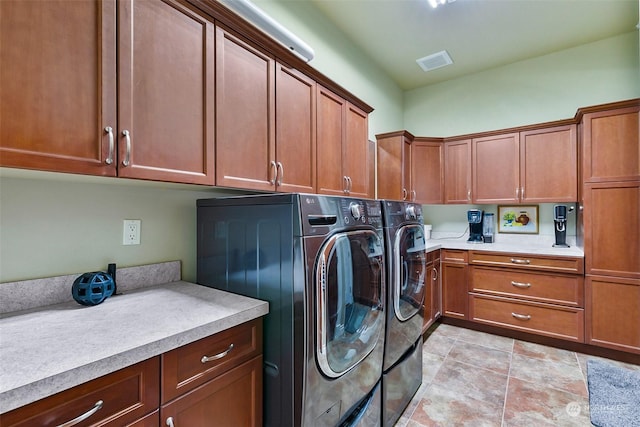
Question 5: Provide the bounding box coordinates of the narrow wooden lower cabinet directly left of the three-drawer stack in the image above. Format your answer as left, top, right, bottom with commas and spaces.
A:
441, 249, 469, 319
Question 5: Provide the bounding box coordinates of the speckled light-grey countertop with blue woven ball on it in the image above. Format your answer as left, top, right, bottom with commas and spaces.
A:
0, 281, 269, 413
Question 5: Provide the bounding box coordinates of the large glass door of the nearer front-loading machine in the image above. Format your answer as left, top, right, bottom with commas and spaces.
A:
315, 230, 385, 378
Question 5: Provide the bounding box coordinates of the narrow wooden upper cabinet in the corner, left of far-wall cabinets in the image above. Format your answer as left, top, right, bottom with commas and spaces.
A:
376, 131, 413, 200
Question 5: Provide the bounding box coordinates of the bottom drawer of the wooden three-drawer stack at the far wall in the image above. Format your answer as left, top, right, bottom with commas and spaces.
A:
469, 294, 584, 342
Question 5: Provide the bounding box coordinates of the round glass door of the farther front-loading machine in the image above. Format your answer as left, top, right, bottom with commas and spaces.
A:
392, 224, 427, 321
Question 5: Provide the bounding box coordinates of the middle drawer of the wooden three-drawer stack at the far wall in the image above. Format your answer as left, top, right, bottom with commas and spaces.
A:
469, 266, 584, 307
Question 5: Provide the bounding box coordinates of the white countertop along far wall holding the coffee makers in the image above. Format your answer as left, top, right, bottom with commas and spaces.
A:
426, 237, 584, 258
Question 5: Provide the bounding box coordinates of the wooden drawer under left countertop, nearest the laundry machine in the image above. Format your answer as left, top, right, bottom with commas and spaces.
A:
162, 319, 262, 403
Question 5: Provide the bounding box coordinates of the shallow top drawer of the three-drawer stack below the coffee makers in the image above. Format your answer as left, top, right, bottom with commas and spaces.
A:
469, 251, 584, 274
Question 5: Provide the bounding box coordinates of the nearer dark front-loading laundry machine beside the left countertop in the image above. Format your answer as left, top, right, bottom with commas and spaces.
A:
197, 194, 386, 427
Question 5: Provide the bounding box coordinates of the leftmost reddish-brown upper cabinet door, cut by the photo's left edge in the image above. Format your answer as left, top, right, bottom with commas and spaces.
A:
0, 0, 117, 176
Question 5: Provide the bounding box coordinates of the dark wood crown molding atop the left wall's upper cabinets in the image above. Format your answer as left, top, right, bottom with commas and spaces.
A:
181, 0, 373, 114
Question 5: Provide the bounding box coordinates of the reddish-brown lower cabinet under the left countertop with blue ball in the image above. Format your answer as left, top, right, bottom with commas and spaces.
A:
0, 318, 263, 427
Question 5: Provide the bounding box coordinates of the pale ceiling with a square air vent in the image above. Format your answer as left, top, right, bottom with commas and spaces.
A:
305, 0, 639, 90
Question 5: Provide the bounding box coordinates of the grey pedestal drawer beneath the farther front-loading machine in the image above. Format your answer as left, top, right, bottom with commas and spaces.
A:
382, 336, 423, 426
